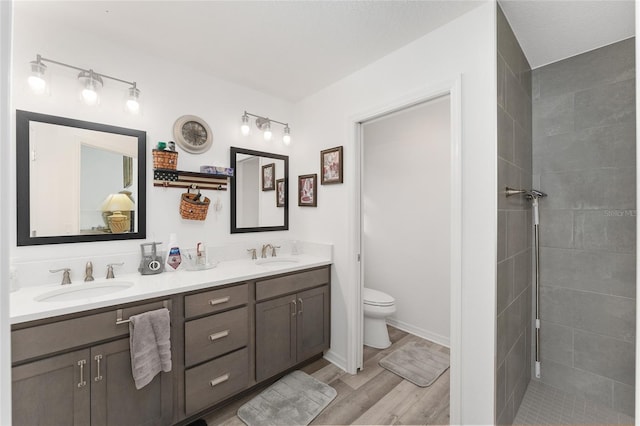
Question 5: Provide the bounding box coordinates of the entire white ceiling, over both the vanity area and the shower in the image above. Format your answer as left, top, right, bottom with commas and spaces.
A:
14, 0, 634, 101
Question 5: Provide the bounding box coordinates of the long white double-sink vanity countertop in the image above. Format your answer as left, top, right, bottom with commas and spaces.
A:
10, 254, 331, 324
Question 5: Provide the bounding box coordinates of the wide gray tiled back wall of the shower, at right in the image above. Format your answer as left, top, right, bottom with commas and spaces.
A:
532, 39, 636, 416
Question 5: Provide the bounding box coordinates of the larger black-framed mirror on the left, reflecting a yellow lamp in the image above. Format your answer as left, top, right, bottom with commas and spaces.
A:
16, 110, 147, 246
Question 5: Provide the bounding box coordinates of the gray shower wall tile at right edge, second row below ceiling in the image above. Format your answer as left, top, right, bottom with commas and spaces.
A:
576, 79, 636, 130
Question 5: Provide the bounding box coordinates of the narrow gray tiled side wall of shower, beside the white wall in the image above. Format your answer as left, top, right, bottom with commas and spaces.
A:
496, 6, 532, 424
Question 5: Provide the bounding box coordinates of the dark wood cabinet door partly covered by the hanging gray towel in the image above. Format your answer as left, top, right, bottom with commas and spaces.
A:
88, 338, 173, 426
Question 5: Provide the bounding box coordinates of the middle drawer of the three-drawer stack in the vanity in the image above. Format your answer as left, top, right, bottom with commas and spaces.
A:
184, 306, 249, 366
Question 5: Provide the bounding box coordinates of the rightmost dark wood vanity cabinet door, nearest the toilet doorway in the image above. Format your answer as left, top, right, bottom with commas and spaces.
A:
296, 286, 330, 362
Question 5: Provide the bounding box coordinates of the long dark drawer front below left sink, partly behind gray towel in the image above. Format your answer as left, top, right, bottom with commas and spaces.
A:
11, 301, 171, 363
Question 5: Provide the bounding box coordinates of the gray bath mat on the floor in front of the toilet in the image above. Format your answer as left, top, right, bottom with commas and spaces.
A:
379, 342, 449, 388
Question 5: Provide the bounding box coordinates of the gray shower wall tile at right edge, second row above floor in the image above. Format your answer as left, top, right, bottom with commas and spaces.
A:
573, 330, 635, 386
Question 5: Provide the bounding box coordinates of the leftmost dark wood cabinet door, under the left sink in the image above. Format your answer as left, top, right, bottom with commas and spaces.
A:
11, 349, 91, 426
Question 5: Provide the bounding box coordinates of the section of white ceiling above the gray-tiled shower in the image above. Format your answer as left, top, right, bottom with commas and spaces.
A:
499, 0, 635, 69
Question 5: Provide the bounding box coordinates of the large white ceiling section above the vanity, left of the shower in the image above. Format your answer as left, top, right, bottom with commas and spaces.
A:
15, 0, 482, 101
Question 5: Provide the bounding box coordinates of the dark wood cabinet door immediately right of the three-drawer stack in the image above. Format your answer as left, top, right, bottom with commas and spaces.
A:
256, 294, 297, 381
